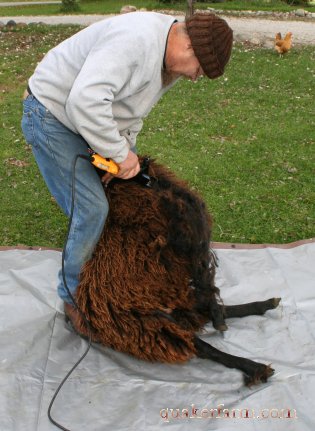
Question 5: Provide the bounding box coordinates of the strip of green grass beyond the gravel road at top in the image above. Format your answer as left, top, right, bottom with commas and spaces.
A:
0, 0, 315, 16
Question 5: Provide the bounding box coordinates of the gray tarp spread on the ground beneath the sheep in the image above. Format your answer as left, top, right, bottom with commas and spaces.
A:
0, 242, 315, 431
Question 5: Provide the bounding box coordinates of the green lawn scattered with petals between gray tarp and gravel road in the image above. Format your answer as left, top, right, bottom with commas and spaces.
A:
0, 26, 315, 247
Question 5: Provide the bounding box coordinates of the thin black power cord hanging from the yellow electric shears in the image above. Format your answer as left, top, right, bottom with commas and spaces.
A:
47, 154, 92, 431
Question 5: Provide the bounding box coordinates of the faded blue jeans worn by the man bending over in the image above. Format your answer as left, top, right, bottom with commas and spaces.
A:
22, 95, 108, 303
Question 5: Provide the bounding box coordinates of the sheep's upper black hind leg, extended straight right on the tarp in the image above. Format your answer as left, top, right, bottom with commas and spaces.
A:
223, 298, 281, 319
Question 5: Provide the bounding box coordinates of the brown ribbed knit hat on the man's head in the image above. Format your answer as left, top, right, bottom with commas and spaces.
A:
186, 13, 233, 79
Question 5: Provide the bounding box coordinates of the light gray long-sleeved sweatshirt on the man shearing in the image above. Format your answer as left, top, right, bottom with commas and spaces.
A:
29, 12, 175, 163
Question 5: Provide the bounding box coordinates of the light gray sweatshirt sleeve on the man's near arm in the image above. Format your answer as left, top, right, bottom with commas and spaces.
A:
66, 37, 144, 163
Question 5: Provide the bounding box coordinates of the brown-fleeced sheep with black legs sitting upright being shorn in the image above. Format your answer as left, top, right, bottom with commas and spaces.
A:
76, 157, 279, 383
